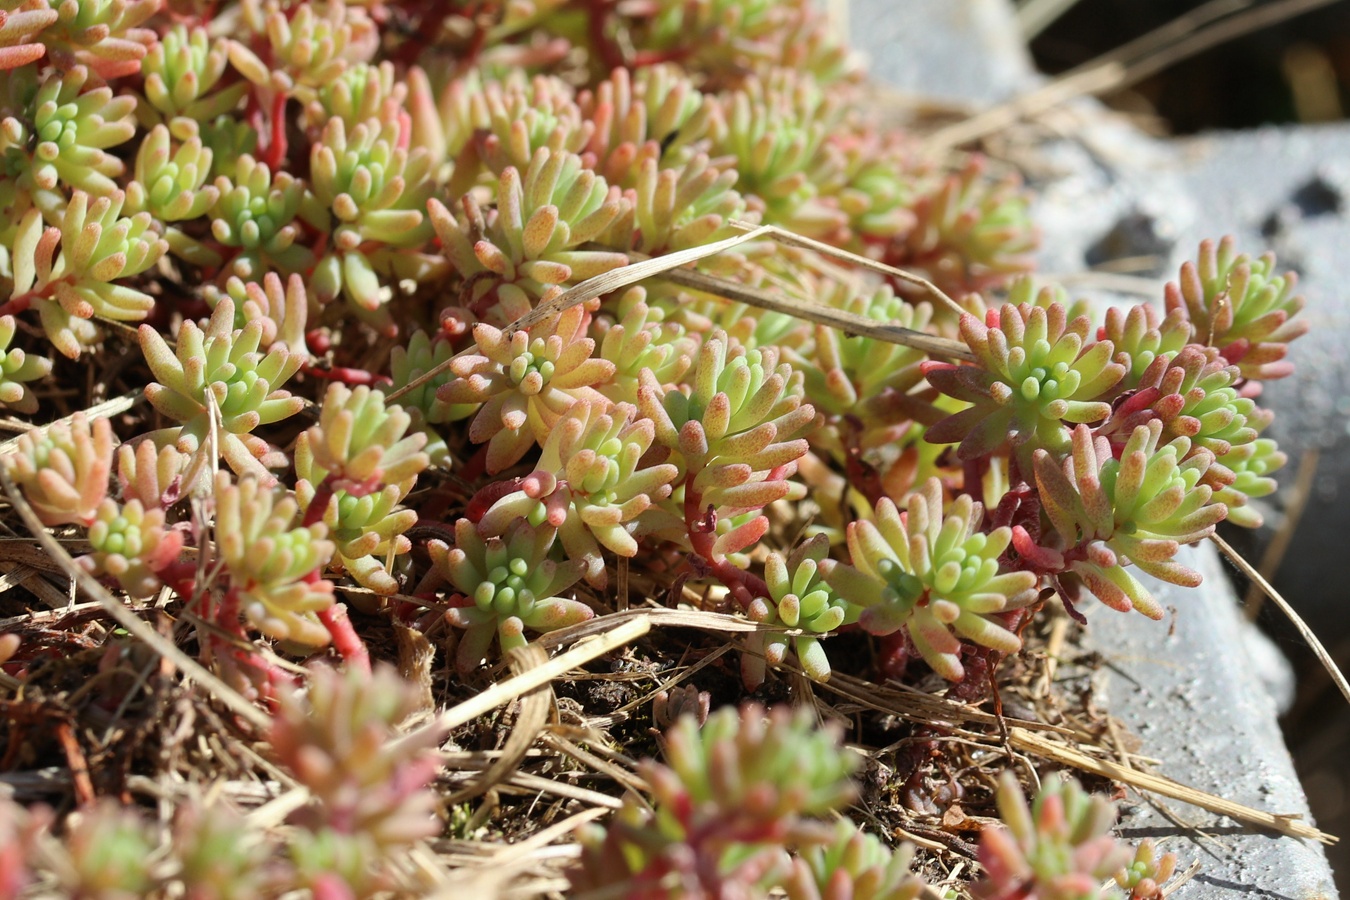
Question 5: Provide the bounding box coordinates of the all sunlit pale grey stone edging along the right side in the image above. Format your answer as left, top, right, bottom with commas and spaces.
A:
851, 0, 1333, 900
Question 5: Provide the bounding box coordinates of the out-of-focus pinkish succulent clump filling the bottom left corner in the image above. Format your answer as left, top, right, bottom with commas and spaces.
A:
0, 665, 441, 900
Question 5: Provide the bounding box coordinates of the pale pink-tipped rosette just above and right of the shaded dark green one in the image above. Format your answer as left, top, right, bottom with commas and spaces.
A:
478, 401, 679, 586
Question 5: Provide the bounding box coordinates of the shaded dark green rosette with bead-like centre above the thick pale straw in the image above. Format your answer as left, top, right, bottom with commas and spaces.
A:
417, 518, 594, 672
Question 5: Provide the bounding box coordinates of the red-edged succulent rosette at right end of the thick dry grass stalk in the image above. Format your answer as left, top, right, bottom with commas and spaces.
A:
921, 304, 1126, 474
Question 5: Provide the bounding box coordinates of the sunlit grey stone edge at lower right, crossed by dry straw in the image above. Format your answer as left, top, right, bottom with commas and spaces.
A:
1085, 546, 1337, 900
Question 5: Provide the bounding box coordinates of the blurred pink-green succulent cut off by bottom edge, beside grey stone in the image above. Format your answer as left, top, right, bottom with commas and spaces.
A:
973, 772, 1130, 900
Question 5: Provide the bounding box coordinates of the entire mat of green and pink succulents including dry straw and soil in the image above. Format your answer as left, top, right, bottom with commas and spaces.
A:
0, 0, 1331, 900
